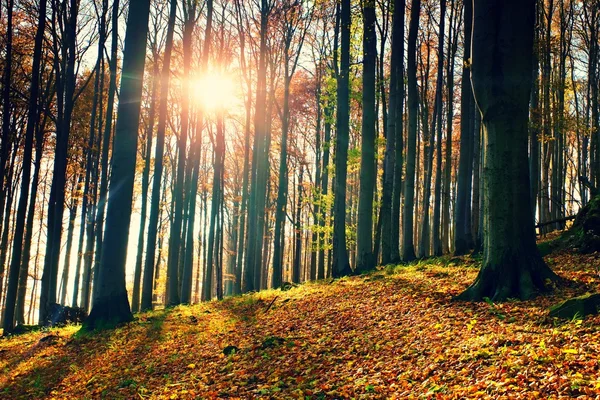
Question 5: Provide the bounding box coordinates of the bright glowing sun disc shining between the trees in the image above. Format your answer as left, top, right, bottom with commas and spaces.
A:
191, 72, 236, 112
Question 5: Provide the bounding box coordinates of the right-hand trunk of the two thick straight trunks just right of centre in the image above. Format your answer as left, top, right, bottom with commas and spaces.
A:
356, 0, 377, 272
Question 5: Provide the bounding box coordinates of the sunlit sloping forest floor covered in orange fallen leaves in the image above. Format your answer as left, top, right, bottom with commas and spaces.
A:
0, 245, 600, 399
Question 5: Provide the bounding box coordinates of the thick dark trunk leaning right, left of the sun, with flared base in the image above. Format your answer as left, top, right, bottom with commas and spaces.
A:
84, 0, 150, 329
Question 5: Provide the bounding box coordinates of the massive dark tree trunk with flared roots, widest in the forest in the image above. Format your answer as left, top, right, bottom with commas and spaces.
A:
458, 0, 559, 301
